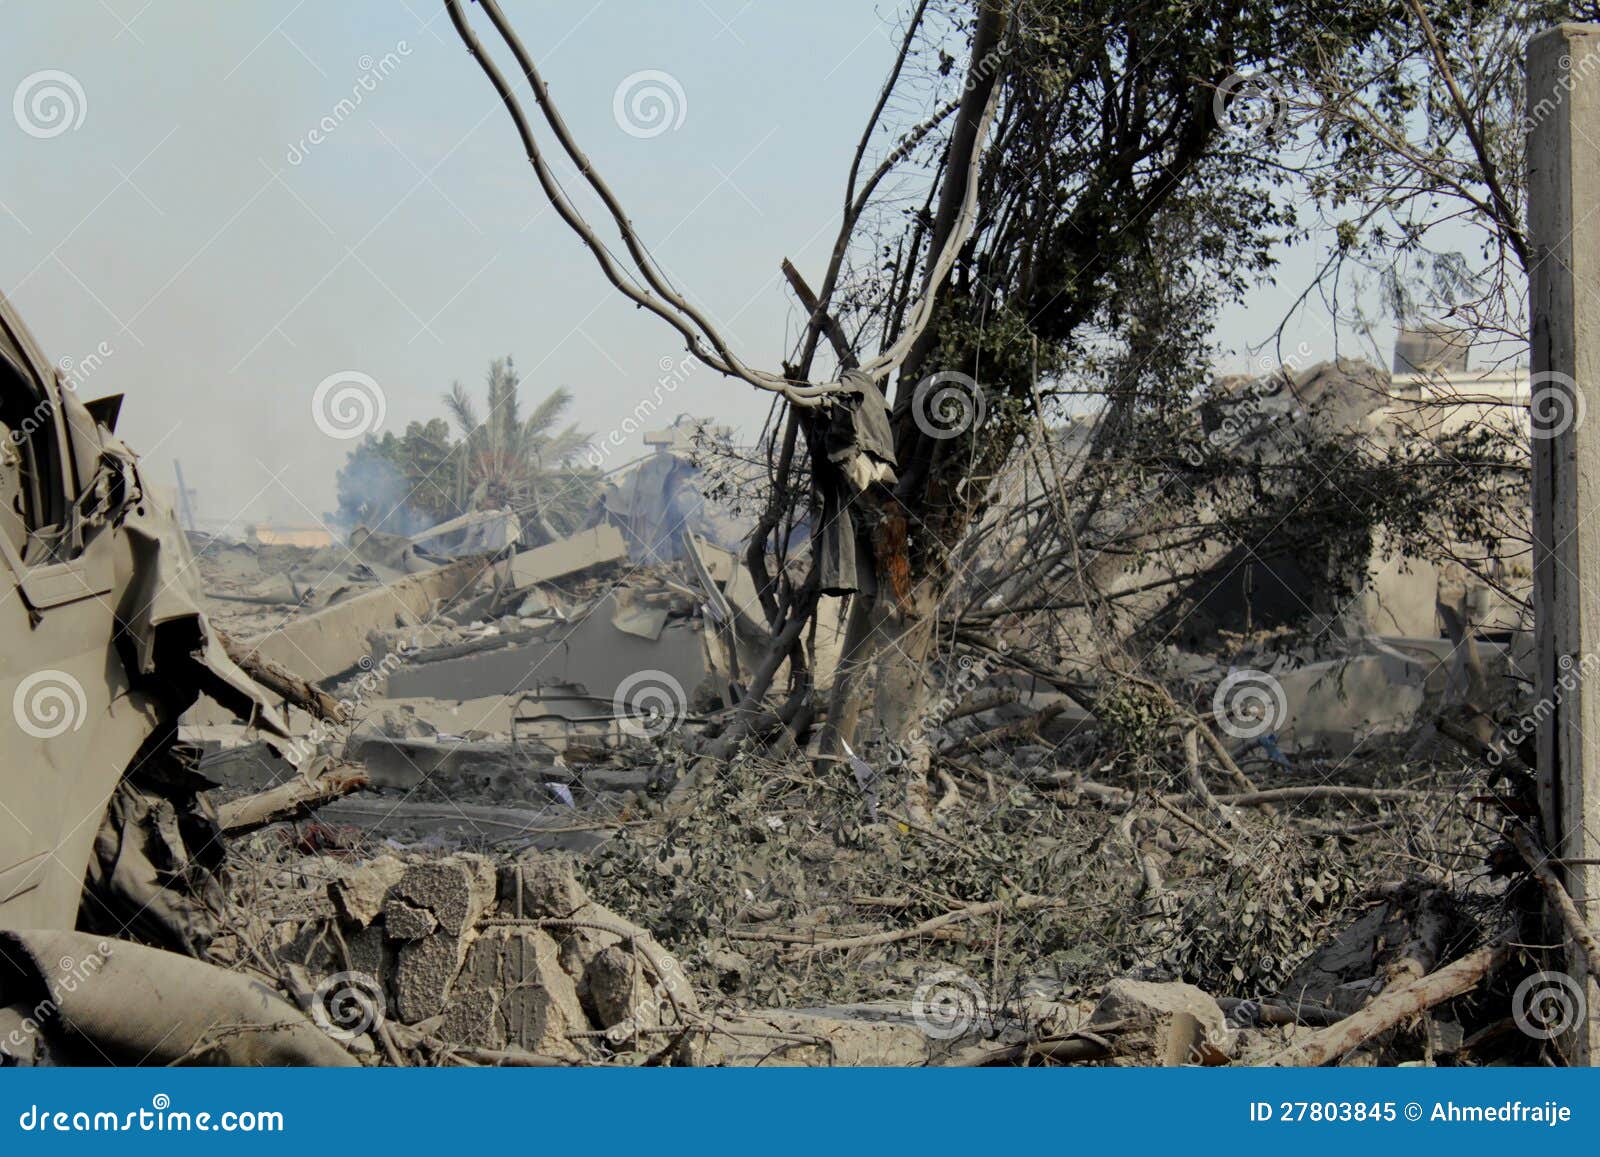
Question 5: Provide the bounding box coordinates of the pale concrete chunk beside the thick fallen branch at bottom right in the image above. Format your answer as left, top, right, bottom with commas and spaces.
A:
1088, 979, 1234, 1066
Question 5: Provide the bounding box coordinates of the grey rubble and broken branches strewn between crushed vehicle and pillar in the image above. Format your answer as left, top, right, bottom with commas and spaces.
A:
152, 476, 1548, 1064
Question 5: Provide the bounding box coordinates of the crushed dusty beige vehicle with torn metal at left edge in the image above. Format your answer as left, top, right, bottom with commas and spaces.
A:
0, 298, 347, 1064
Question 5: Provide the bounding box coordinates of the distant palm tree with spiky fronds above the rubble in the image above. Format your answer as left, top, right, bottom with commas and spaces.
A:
445, 357, 592, 539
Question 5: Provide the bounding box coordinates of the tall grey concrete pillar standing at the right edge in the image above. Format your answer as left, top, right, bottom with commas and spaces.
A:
1526, 24, 1600, 1064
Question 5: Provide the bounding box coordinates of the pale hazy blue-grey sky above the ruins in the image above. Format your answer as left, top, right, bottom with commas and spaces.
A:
0, 0, 1334, 528
